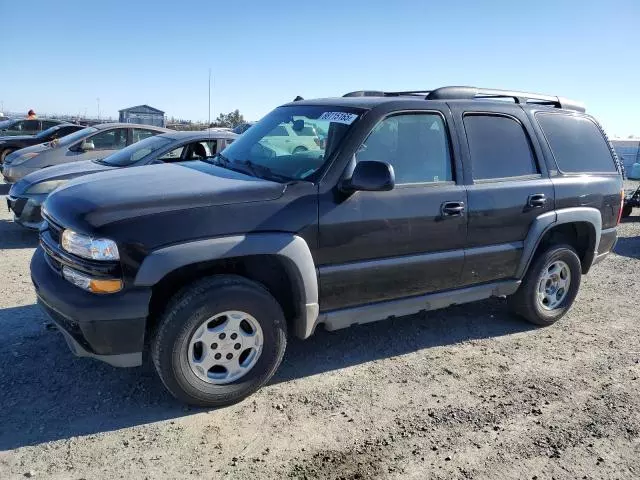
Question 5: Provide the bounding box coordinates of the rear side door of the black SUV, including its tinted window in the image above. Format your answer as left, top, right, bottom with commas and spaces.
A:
451, 105, 554, 285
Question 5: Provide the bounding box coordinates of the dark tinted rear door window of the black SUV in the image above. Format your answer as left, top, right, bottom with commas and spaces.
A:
464, 115, 539, 180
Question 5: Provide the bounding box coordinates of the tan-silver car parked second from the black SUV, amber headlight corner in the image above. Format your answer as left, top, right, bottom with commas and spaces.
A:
2, 123, 170, 183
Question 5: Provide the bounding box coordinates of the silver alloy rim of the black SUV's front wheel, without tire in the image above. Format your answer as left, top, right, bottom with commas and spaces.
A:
187, 310, 264, 385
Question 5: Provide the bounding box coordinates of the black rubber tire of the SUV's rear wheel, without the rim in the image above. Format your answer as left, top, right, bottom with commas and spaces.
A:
507, 245, 582, 326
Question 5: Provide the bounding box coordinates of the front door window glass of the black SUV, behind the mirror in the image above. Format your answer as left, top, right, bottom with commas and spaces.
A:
356, 114, 453, 184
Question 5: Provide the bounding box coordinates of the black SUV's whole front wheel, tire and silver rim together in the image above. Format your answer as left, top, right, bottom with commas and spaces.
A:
151, 275, 287, 407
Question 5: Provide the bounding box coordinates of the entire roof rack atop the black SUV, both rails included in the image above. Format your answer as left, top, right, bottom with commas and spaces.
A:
343, 87, 585, 112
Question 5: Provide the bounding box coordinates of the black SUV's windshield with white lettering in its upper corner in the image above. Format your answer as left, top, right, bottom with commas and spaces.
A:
222, 105, 362, 181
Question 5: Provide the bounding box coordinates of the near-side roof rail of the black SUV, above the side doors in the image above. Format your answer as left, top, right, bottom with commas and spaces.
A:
426, 87, 585, 112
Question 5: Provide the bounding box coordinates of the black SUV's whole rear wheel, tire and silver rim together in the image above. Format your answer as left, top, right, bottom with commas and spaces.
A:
508, 245, 582, 326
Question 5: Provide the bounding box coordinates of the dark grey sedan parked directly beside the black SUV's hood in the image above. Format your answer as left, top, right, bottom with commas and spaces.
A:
7, 131, 238, 229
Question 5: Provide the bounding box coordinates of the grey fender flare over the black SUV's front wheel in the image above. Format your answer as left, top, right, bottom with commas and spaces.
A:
134, 233, 319, 338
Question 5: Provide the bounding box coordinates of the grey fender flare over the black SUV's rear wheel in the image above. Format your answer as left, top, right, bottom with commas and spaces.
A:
516, 207, 602, 278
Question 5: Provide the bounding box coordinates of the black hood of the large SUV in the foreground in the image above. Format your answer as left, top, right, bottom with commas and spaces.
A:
44, 161, 286, 232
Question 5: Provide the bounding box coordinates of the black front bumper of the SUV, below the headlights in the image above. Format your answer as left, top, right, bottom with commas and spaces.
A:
31, 246, 151, 367
